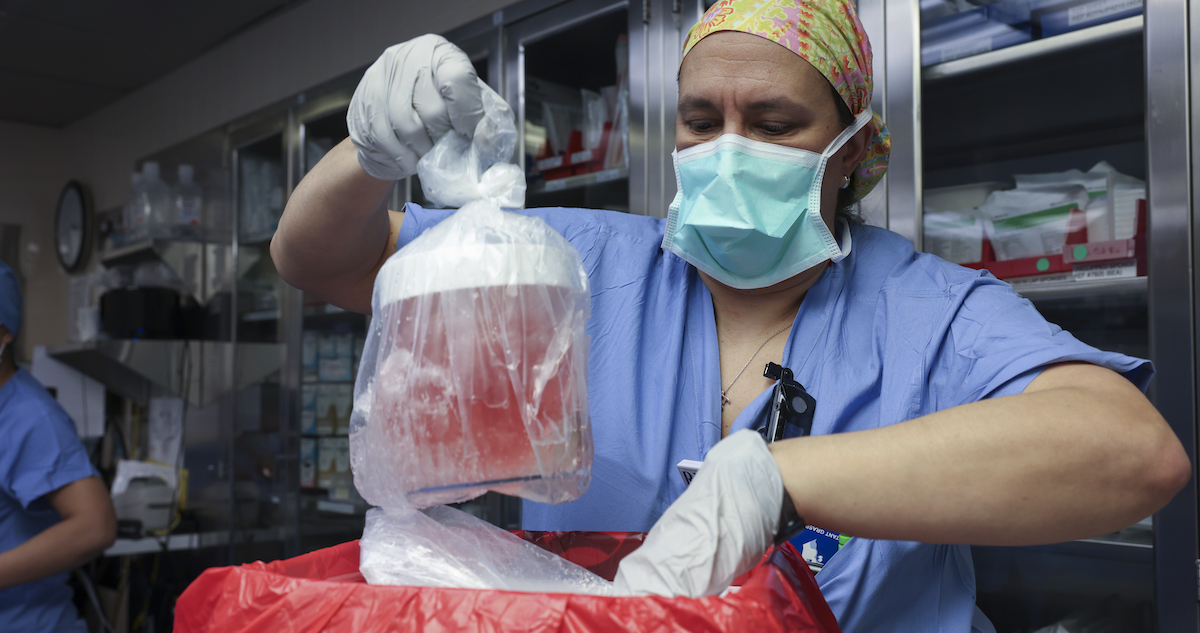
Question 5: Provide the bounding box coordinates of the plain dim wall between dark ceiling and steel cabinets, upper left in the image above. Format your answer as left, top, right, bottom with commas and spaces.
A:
9, 0, 515, 350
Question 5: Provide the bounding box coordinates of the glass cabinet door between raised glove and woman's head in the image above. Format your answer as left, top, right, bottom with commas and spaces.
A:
506, 0, 630, 211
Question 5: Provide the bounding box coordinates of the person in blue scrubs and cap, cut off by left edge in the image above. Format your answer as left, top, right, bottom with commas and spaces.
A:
0, 263, 116, 633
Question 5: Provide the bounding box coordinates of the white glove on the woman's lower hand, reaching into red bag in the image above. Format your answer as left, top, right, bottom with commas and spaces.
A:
613, 429, 784, 598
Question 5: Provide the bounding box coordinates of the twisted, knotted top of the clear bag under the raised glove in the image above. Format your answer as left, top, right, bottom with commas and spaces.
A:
416, 89, 526, 209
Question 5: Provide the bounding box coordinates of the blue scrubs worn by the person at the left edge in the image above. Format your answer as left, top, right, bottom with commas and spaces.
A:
0, 369, 96, 633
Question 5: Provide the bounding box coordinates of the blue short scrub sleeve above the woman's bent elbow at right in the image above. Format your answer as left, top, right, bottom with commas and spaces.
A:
930, 277, 1153, 405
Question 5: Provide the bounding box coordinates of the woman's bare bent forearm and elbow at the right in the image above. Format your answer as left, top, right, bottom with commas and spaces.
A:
772, 364, 1192, 545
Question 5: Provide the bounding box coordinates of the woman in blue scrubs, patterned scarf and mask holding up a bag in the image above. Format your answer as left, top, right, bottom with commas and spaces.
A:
271, 0, 1190, 632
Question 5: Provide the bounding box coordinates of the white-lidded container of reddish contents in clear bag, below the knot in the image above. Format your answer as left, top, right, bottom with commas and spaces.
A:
350, 201, 592, 508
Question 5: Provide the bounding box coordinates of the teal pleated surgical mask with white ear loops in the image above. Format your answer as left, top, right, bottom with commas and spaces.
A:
662, 109, 871, 289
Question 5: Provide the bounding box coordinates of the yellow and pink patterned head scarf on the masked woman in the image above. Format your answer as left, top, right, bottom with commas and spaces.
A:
683, 0, 892, 201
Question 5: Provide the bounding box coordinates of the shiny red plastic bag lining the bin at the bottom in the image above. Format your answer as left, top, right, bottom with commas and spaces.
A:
174, 531, 839, 633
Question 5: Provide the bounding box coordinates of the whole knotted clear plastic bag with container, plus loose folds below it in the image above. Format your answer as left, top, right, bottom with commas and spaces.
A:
350, 77, 595, 593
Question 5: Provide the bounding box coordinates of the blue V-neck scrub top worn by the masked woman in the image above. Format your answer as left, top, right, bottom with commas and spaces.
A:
398, 205, 1152, 633
